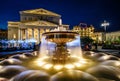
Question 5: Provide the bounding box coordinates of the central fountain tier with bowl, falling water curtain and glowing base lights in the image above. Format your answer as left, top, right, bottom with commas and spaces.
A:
33, 20, 94, 73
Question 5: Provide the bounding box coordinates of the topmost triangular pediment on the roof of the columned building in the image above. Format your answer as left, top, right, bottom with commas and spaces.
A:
20, 8, 61, 17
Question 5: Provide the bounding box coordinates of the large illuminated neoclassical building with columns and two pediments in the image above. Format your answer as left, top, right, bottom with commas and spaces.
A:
8, 8, 69, 42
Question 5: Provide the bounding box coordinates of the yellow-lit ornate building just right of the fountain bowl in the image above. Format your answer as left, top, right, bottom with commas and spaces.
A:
73, 23, 102, 43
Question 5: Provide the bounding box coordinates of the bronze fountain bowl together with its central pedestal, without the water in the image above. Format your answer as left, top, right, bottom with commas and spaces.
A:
43, 31, 78, 64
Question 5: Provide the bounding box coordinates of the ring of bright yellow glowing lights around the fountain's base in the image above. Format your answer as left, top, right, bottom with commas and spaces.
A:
33, 56, 93, 72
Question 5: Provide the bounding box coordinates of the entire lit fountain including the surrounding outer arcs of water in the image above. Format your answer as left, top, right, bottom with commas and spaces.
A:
0, 20, 120, 81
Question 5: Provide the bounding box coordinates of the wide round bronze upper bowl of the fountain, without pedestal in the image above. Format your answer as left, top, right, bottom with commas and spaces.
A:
43, 31, 79, 44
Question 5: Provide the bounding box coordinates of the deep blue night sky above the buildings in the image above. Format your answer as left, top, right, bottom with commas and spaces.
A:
0, 0, 120, 31
